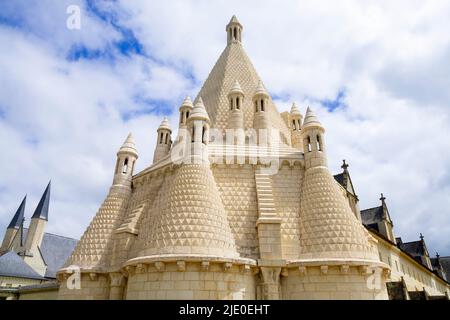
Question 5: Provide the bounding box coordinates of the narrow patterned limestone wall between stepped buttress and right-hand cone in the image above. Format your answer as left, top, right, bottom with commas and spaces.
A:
272, 165, 304, 259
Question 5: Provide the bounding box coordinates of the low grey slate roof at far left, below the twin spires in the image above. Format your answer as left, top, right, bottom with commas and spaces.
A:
0, 251, 44, 280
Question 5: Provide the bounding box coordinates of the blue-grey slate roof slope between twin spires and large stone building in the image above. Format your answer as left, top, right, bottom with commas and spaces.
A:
23, 228, 78, 278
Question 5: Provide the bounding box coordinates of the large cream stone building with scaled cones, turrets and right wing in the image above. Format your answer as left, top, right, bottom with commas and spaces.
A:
58, 16, 449, 299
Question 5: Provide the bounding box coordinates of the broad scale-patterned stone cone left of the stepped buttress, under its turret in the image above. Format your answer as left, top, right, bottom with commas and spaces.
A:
136, 164, 239, 258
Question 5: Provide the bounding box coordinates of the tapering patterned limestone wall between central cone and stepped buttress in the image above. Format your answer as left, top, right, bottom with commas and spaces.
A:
212, 164, 259, 259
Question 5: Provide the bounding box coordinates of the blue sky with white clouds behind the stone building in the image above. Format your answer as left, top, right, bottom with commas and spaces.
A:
0, 0, 450, 255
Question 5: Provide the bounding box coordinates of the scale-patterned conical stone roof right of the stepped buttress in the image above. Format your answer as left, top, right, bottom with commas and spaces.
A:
300, 166, 379, 261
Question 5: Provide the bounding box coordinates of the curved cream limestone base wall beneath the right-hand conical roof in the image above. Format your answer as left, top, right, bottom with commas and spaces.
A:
281, 266, 388, 300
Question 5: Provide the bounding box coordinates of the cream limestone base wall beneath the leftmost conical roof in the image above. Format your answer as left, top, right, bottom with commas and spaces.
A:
58, 273, 109, 300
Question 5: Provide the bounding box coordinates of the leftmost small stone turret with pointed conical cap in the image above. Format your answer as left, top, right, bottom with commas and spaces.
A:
113, 133, 138, 188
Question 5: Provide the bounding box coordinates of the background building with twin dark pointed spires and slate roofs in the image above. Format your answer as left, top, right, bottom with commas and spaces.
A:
0, 183, 77, 299
